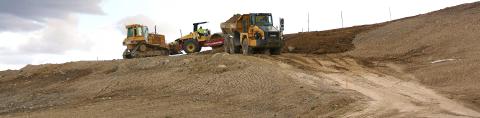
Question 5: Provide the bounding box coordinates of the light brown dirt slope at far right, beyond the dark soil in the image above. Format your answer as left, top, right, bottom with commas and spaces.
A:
348, 2, 480, 110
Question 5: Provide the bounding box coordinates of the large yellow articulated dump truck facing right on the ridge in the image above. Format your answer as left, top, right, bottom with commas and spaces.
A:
220, 13, 284, 55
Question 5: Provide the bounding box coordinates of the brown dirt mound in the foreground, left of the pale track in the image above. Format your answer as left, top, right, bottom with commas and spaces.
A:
0, 53, 362, 117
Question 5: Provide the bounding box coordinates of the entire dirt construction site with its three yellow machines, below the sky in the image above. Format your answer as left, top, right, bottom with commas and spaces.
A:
0, 2, 480, 118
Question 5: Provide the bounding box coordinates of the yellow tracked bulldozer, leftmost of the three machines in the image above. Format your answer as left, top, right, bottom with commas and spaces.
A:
123, 24, 179, 59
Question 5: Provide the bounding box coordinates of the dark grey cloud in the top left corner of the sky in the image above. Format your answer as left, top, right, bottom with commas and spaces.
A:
0, 0, 103, 32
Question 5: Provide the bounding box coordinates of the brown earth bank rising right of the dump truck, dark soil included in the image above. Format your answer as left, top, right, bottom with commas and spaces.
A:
284, 2, 480, 114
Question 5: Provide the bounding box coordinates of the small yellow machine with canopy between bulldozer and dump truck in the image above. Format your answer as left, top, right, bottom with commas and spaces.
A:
175, 22, 224, 54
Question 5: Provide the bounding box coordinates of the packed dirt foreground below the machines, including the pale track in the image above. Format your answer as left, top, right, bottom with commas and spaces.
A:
0, 53, 480, 117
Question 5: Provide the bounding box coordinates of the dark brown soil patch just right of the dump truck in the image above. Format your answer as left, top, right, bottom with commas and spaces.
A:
283, 24, 383, 54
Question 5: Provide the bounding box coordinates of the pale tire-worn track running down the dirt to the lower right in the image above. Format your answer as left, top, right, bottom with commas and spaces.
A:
261, 54, 480, 118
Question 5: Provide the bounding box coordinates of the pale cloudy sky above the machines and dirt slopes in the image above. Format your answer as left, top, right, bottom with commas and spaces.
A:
0, 0, 475, 70
